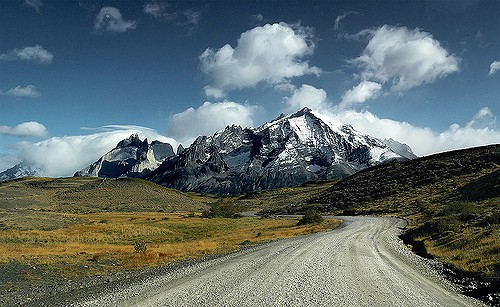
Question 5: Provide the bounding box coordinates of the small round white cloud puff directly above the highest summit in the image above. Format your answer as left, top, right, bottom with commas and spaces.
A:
285, 84, 328, 112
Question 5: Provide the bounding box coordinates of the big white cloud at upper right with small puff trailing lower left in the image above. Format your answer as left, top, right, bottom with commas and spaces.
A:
341, 25, 460, 106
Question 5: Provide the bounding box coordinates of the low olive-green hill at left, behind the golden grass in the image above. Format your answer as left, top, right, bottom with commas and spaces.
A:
0, 177, 208, 217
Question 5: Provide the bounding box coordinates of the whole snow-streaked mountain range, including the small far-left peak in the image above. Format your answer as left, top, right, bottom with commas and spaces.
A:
0, 108, 416, 195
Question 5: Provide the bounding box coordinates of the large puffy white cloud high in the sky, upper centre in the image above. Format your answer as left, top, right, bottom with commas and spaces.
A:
199, 23, 321, 95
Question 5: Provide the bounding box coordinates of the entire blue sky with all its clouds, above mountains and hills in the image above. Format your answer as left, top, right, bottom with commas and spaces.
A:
0, 0, 500, 176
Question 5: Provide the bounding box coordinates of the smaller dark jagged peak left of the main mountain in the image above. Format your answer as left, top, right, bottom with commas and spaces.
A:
75, 134, 174, 178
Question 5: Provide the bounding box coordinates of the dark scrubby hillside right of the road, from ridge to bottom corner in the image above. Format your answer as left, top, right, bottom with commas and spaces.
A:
299, 145, 500, 303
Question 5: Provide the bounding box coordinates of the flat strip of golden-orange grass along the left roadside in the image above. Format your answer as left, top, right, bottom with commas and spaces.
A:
0, 212, 339, 284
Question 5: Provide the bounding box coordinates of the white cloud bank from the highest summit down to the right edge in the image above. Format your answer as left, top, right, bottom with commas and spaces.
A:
285, 84, 500, 156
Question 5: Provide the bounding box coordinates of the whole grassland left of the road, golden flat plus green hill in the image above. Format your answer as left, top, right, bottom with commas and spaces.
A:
0, 178, 340, 289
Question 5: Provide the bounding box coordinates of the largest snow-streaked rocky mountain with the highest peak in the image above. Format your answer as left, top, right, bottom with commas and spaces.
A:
146, 108, 408, 195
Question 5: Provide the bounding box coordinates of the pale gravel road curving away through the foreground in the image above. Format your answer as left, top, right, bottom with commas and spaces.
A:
77, 217, 482, 307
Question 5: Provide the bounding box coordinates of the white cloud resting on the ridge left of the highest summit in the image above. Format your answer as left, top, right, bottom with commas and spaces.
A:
169, 101, 255, 144
